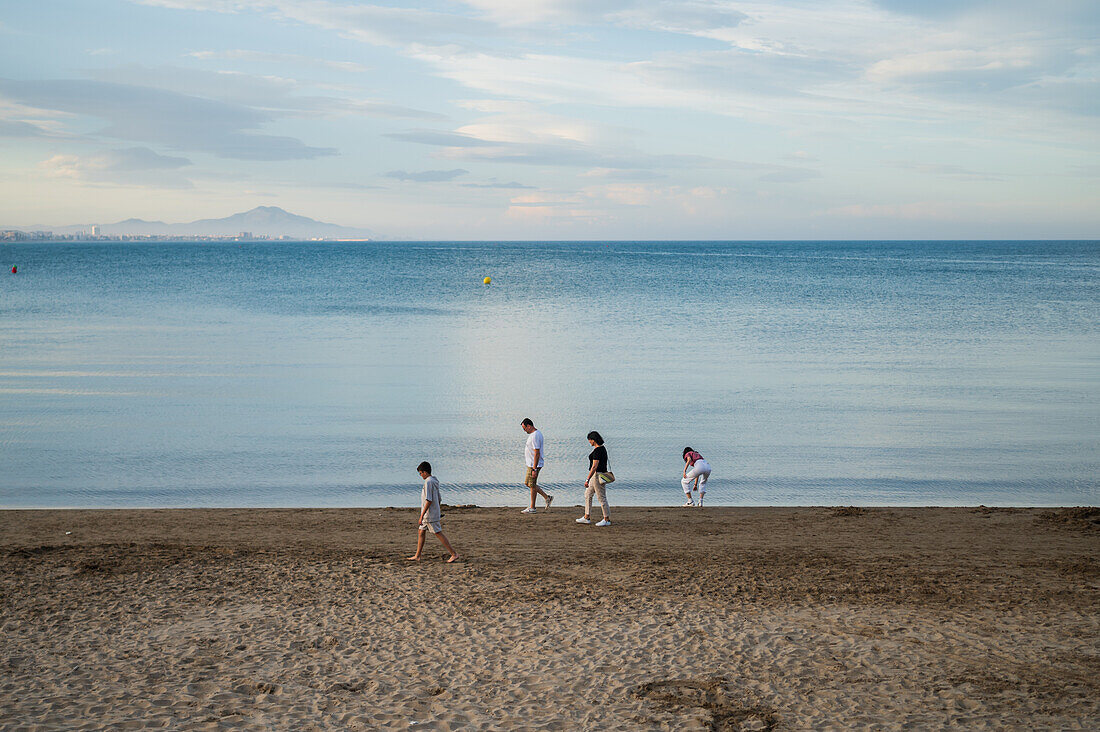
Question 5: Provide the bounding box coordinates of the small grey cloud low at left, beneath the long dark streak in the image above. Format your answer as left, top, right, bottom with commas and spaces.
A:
40, 148, 191, 188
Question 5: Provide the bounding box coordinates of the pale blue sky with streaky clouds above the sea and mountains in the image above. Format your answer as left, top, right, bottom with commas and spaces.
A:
0, 0, 1100, 240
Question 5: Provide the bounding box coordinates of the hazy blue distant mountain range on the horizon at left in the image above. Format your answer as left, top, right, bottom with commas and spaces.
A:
7, 206, 374, 239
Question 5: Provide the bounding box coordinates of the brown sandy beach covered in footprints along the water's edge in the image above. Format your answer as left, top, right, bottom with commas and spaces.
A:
0, 506, 1100, 730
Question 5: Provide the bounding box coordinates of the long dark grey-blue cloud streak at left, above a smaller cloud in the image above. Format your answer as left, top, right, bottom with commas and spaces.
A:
0, 79, 337, 161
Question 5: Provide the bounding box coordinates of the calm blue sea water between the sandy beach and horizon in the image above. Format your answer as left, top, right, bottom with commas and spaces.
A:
0, 242, 1100, 507
